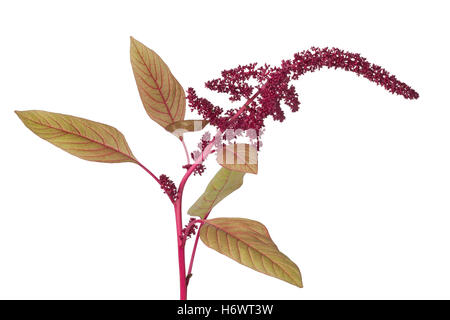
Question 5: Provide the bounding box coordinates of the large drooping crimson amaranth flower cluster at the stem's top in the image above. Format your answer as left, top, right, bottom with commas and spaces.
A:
187, 47, 419, 132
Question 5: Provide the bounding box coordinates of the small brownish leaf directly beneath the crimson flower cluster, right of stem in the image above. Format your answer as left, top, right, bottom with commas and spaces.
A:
217, 143, 258, 174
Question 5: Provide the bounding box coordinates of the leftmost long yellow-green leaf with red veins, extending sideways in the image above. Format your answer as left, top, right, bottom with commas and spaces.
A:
16, 110, 138, 163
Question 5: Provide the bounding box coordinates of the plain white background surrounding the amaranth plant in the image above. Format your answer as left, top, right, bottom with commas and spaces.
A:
0, 1, 450, 299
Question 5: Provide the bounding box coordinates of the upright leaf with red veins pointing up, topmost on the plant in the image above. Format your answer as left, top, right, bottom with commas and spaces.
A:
130, 37, 186, 128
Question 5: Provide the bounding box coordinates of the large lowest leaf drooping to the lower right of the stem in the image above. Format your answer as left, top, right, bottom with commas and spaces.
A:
200, 218, 303, 288
